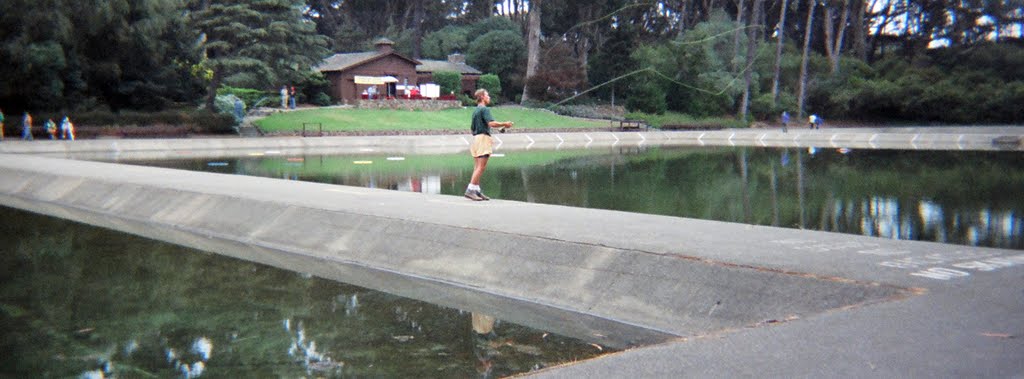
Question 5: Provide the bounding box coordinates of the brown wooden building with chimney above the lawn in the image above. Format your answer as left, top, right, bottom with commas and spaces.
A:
313, 38, 480, 103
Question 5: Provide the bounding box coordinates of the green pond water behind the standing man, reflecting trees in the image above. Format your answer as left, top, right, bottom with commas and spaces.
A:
134, 146, 1024, 249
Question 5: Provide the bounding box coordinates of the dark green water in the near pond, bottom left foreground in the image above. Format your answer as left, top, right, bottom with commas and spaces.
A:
0, 207, 614, 378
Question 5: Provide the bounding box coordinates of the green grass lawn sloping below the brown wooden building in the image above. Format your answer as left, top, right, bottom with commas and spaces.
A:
256, 107, 609, 133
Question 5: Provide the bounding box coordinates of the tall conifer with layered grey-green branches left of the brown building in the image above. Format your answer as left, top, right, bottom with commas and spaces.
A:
189, 0, 327, 110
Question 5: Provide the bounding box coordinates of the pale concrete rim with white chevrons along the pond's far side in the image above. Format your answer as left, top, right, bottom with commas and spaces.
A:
0, 126, 1024, 159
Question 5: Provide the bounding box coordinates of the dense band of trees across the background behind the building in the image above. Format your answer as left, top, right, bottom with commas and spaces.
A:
0, 0, 1024, 123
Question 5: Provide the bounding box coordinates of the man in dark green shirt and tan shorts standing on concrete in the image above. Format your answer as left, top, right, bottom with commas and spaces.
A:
466, 89, 512, 201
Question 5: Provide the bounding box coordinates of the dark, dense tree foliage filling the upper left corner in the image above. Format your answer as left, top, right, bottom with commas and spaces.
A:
0, 0, 194, 111
